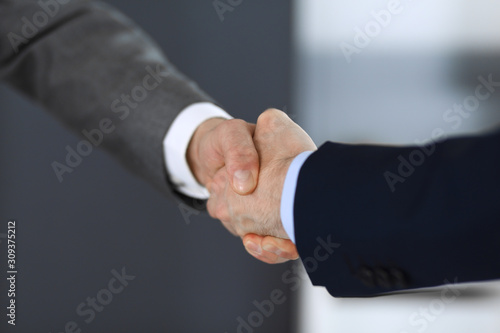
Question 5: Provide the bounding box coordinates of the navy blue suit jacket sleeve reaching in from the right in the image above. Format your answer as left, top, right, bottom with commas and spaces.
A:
294, 127, 500, 296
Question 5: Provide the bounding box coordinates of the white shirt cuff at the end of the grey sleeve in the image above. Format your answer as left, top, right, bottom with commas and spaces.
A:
163, 102, 232, 199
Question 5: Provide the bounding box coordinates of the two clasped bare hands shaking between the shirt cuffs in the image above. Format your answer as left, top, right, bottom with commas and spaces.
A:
186, 109, 317, 263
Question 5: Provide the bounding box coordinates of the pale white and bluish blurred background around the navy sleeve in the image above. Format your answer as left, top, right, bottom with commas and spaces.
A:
292, 0, 500, 333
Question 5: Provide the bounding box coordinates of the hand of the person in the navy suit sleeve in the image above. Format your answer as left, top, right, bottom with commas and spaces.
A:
207, 109, 316, 262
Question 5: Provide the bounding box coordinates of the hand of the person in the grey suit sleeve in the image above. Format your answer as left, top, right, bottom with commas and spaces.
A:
186, 118, 259, 195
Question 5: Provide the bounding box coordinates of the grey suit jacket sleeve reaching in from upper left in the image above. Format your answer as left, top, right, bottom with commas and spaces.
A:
0, 0, 217, 206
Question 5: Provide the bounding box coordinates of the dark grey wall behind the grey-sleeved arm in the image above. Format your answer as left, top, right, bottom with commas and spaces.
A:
0, 0, 293, 332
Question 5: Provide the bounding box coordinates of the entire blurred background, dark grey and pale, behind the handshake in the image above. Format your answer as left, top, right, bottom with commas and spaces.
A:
0, 0, 500, 333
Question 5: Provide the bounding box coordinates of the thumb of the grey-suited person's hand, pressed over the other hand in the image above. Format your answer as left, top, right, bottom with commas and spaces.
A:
221, 119, 259, 195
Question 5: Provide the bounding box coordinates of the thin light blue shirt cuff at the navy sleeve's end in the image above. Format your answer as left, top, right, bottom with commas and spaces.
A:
280, 151, 313, 244
